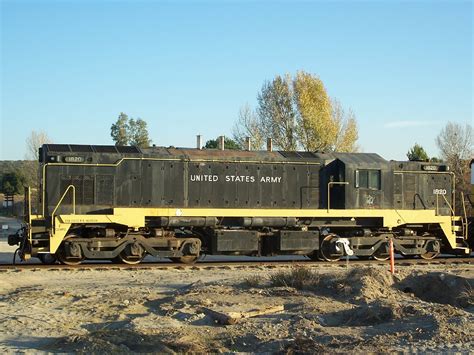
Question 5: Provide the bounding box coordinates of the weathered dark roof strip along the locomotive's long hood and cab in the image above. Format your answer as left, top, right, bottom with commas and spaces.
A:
42, 144, 387, 165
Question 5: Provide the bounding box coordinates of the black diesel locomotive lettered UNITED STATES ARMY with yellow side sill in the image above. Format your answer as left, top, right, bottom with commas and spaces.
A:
10, 144, 470, 264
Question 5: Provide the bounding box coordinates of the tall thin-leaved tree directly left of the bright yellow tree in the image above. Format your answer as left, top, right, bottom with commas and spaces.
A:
257, 75, 298, 151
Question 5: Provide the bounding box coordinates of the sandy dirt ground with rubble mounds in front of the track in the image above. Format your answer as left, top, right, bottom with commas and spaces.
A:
0, 258, 474, 353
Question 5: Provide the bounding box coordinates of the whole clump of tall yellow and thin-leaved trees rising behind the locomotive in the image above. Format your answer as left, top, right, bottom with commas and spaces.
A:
237, 71, 358, 152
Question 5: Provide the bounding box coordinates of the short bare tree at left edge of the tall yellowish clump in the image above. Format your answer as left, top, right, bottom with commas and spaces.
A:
232, 104, 265, 150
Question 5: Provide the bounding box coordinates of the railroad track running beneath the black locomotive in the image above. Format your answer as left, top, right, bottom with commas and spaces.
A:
0, 257, 474, 272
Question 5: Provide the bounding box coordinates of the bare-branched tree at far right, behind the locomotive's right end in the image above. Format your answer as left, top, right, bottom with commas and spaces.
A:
436, 122, 473, 213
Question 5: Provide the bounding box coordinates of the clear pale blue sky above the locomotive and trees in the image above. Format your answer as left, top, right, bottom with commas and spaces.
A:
0, 0, 473, 160
